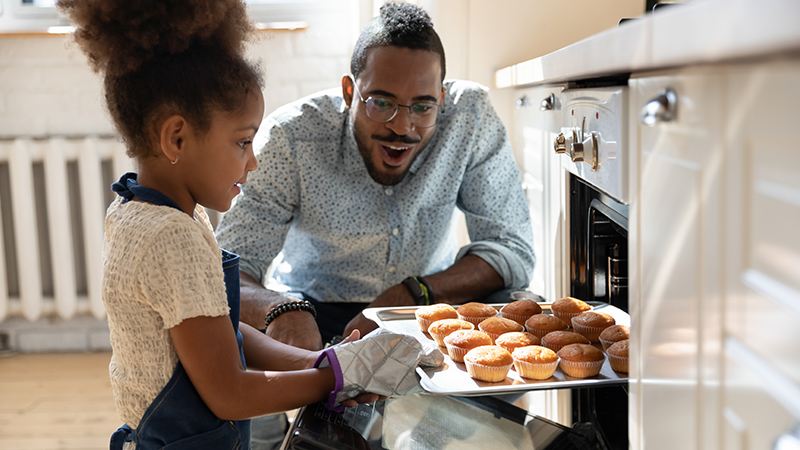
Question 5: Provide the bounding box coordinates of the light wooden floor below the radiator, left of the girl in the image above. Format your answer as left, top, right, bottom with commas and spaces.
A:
0, 353, 121, 450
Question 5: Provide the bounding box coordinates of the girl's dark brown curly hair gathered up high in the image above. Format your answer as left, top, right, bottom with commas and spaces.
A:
57, 0, 263, 158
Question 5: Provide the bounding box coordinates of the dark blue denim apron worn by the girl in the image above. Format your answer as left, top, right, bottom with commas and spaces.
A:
110, 173, 250, 450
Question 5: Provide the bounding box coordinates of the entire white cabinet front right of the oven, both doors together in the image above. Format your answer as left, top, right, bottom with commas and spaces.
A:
629, 61, 800, 450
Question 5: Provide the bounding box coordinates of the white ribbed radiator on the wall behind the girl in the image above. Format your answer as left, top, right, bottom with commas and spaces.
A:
0, 136, 133, 322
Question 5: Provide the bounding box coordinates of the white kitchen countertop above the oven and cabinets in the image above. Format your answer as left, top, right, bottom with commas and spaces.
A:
495, 0, 800, 88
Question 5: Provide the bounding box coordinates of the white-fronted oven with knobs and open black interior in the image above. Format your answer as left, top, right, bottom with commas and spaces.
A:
552, 79, 635, 449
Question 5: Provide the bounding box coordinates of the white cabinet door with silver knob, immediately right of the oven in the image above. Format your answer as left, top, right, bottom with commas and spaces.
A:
630, 70, 724, 450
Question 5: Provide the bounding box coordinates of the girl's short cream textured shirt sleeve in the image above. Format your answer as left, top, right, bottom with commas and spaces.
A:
138, 223, 230, 329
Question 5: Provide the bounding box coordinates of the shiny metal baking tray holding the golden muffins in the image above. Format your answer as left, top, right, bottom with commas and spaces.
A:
363, 302, 631, 397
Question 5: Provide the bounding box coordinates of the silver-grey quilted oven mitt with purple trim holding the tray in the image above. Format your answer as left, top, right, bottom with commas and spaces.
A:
314, 328, 444, 412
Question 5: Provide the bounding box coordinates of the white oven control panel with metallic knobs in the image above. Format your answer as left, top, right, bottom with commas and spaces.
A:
553, 86, 629, 204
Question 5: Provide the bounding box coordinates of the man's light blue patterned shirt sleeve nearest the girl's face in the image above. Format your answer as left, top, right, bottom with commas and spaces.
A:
217, 119, 299, 281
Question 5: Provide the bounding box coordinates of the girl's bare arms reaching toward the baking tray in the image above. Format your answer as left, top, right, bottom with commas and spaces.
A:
170, 316, 335, 420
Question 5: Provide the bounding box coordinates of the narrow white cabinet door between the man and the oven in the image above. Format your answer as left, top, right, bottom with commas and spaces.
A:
514, 87, 568, 301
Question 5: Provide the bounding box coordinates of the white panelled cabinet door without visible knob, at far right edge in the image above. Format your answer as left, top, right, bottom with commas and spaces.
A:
721, 60, 800, 449
